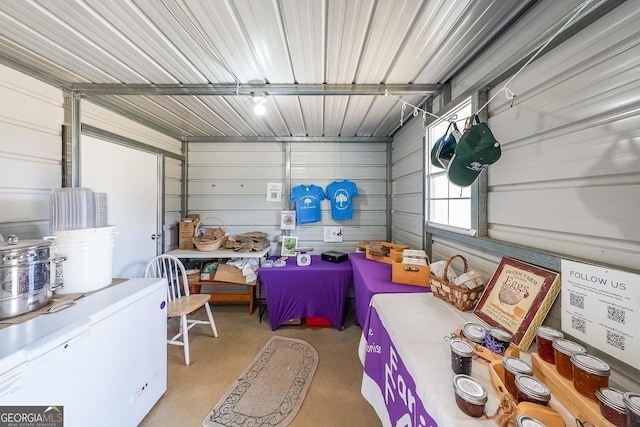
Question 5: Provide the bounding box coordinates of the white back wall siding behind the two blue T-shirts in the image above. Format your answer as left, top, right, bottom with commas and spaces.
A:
188, 142, 387, 253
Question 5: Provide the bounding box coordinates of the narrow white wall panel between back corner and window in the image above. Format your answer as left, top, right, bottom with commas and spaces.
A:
391, 118, 424, 249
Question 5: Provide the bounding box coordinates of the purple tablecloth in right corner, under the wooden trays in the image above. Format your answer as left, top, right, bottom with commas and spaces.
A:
349, 253, 431, 326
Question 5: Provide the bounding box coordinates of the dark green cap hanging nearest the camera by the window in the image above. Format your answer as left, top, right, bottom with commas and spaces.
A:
447, 115, 502, 187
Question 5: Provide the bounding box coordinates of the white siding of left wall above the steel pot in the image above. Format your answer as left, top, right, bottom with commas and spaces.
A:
0, 65, 64, 239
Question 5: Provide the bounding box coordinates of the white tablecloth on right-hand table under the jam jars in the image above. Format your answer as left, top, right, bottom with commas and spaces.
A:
359, 294, 575, 427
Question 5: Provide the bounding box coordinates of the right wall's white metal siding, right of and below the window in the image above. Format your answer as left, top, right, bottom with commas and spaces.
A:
433, 2, 640, 389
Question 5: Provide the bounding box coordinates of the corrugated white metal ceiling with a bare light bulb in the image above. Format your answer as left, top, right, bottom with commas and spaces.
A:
0, 0, 580, 140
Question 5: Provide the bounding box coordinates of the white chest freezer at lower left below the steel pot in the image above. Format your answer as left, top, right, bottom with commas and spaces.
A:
0, 279, 167, 427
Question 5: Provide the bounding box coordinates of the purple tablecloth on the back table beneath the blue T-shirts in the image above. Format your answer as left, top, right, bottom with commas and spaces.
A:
258, 255, 353, 331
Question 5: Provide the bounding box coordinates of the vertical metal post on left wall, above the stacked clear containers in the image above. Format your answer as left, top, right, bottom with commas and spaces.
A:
62, 90, 81, 187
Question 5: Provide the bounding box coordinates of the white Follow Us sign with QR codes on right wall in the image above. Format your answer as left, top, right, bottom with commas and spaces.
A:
561, 260, 640, 366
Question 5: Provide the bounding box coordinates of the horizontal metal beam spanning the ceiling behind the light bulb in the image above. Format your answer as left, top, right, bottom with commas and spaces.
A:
72, 83, 441, 97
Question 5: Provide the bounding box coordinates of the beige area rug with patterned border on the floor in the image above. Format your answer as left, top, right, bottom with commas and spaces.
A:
202, 336, 318, 427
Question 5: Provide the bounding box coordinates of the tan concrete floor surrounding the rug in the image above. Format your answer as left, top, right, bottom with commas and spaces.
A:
140, 305, 381, 427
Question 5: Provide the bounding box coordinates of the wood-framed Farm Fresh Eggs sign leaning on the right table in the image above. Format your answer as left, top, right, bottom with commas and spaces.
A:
473, 257, 560, 351
